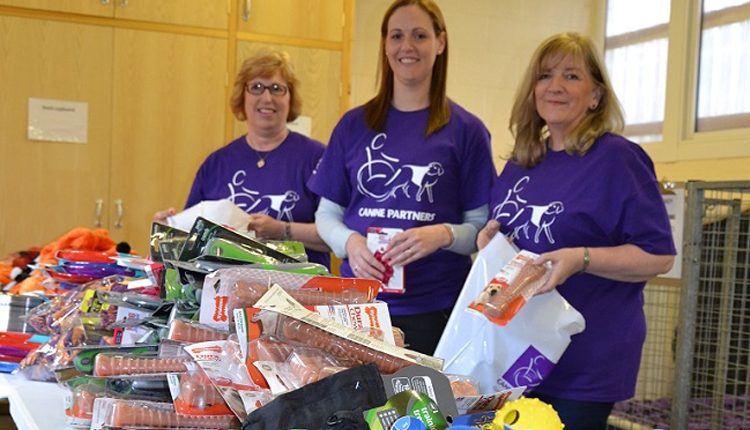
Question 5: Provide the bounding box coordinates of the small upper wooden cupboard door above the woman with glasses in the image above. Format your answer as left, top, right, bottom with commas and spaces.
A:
236, 0, 344, 42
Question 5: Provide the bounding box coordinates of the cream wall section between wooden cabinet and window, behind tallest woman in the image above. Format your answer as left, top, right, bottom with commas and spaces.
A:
351, 0, 603, 168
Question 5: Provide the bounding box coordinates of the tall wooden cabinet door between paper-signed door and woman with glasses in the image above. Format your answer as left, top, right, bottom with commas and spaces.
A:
109, 29, 227, 254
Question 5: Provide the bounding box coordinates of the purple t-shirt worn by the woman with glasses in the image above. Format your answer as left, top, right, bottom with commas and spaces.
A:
185, 131, 331, 267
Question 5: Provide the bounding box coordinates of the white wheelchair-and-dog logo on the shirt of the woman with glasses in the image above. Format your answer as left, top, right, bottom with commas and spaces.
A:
227, 170, 299, 222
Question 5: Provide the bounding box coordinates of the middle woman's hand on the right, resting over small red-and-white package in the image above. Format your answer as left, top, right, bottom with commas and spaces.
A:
383, 224, 451, 266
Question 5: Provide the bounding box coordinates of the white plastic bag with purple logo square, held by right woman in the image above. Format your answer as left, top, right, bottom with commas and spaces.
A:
434, 234, 585, 394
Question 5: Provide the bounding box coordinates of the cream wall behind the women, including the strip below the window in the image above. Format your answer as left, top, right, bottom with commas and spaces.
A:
351, 0, 750, 182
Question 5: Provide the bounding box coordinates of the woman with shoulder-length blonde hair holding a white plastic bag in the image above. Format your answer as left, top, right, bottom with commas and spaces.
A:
477, 33, 675, 430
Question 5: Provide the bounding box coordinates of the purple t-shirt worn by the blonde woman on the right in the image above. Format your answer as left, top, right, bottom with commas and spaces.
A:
490, 134, 675, 402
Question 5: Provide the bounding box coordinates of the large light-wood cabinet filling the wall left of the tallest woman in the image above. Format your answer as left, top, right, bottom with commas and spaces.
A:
0, 0, 352, 256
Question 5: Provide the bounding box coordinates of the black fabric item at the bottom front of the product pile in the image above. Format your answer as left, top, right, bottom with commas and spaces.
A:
242, 363, 388, 430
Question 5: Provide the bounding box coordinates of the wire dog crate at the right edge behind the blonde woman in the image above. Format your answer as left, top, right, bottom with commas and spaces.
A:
609, 181, 750, 430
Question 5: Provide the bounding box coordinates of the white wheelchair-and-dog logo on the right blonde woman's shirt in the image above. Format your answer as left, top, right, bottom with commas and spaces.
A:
492, 176, 565, 244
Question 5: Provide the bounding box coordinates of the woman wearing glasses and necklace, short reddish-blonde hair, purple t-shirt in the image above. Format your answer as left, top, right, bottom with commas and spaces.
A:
154, 51, 330, 267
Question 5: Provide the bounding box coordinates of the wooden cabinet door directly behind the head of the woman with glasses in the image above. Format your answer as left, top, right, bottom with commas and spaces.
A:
232, 42, 341, 143
